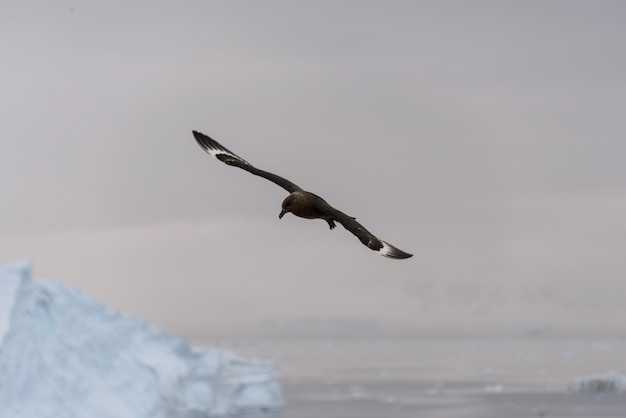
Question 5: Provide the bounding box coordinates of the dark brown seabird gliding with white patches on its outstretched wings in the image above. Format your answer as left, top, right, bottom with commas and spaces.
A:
193, 131, 413, 259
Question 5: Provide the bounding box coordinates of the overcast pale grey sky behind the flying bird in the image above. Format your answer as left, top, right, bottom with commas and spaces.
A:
0, 0, 626, 335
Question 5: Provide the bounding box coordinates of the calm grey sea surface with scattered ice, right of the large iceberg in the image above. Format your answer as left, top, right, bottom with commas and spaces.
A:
197, 335, 626, 418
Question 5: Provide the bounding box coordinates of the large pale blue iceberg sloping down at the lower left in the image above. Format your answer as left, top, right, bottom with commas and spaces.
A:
0, 262, 283, 418
